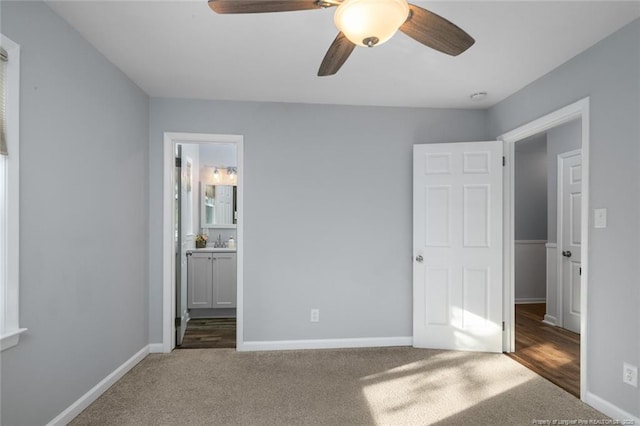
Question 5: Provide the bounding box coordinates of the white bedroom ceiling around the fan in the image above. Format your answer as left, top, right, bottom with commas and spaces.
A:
47, 0, 640, 108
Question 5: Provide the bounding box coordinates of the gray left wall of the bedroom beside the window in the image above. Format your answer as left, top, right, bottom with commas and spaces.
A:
0, 1, 148, 426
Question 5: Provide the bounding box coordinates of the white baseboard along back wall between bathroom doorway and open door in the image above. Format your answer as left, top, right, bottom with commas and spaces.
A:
237, 336, 413, 352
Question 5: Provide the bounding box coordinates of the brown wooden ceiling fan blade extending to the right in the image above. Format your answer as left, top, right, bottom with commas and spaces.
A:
400, 4, 476, 56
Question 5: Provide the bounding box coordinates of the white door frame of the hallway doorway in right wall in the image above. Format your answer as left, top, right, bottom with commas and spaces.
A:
498, 97, 589, 400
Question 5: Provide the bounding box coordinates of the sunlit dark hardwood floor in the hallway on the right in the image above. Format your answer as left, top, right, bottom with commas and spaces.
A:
507, 303, 580, 398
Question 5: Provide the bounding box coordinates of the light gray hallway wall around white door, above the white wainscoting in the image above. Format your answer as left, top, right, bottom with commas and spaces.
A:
547, 120, 582, 243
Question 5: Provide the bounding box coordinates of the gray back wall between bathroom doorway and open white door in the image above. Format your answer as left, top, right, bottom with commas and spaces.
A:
149, 99, 487, 342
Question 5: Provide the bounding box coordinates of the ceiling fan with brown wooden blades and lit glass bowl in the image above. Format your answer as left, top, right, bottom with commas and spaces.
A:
209, 0, 475, 77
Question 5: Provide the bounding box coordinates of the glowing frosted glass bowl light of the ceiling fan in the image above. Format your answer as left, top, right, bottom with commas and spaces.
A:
334, 0, 409, 47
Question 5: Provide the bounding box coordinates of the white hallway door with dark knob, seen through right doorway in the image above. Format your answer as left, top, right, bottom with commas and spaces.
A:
558, 150, 582, 333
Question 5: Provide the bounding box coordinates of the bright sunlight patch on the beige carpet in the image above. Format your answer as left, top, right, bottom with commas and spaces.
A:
360, 352, 532, 425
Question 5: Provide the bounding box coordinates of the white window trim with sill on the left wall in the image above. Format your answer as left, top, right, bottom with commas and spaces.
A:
0, 34, 27, 351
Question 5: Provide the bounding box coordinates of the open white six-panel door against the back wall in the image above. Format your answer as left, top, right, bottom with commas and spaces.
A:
413, 141, 503, 352
